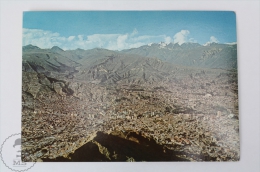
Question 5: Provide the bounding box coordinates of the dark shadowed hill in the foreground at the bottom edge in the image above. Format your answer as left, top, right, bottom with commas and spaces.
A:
43, 132, 188, 162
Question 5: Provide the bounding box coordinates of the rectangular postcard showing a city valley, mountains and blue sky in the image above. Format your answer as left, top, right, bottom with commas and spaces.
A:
21, 11, 240, 162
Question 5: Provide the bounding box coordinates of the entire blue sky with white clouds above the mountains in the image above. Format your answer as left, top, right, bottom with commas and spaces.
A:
23, 11, 236, 50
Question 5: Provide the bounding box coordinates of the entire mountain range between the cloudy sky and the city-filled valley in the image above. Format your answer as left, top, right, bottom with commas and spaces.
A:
23, 42, 237, 84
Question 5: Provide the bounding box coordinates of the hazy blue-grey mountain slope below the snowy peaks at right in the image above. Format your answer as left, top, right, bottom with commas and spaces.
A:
123, 43, 237, 69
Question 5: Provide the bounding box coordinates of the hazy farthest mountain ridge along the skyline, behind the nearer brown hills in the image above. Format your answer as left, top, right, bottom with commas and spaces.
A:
23, 42, 237, 69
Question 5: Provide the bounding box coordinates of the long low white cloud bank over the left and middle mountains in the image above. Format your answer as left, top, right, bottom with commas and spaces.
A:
23, 29, 175, 50
